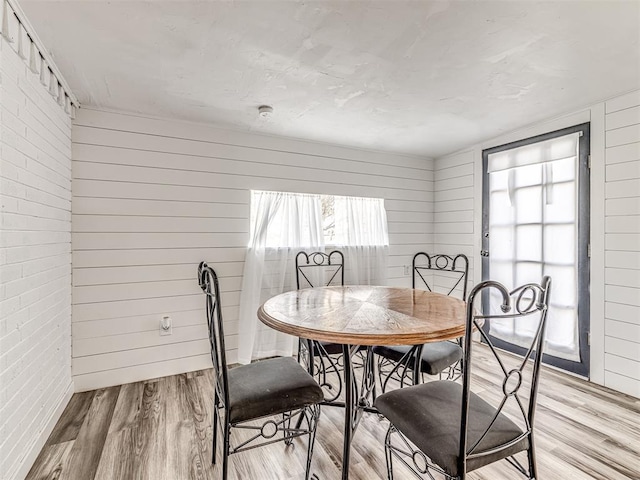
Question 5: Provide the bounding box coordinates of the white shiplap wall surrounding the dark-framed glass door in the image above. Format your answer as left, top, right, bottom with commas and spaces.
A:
434, 91, 640, 397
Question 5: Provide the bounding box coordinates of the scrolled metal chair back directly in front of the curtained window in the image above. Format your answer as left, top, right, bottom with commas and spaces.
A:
296, 250, 344, 290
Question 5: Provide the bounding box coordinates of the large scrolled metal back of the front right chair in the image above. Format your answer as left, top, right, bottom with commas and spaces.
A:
459, 277, 551, 474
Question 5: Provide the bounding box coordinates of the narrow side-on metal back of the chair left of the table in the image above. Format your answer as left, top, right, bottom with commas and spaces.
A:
198, 262, 229, 407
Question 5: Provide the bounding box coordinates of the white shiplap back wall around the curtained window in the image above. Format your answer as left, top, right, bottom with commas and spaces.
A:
73, 109, 433, 390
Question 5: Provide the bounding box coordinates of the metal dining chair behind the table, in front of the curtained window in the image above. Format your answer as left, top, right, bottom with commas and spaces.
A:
295, 250, 344, 403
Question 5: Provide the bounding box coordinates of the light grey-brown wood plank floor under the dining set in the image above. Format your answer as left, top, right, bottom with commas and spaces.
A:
27, 348, 640, 480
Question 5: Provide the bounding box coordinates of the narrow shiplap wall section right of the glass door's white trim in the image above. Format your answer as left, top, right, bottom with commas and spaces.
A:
604, 91, 640, 397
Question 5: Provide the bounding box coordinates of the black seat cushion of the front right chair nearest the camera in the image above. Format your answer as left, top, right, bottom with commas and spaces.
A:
374, 380, 529, 477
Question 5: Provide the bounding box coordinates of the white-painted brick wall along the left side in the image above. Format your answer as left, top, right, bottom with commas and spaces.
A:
0, 35, 73, 480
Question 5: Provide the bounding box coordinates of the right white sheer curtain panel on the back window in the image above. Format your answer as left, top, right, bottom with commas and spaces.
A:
334, 197, 389, 285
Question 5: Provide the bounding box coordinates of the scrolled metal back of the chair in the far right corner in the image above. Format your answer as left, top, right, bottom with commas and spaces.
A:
411, 252, 469, 300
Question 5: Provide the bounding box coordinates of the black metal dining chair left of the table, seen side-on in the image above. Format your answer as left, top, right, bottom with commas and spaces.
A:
198, 262, 323, 480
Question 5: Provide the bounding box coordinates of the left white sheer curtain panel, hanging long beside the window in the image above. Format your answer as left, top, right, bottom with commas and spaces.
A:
238, 191, 324, 364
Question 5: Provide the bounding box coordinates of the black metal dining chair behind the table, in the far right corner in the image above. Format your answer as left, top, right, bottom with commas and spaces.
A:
373, 252, 469, 392
